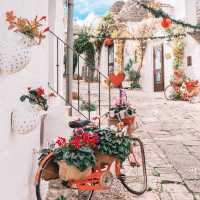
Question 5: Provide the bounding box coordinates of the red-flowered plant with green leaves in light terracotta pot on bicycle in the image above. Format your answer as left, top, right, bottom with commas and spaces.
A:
40, 129, 98, 181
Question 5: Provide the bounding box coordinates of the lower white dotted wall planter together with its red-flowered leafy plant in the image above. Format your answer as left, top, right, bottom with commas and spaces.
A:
12, 87, 48, 134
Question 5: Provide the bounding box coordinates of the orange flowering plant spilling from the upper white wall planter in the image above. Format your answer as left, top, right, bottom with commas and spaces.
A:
6, 11, 49, 44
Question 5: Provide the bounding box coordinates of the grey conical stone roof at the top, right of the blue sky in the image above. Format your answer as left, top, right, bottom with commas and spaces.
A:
117, 0, 149, 22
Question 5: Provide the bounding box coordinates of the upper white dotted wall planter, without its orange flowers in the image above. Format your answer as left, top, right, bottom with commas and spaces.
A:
0, 34, 36, 75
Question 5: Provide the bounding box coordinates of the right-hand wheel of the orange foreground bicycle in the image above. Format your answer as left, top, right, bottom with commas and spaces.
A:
119, 138, 147, 195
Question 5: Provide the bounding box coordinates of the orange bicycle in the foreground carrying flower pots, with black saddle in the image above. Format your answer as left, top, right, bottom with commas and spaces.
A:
35, 115, 147, 200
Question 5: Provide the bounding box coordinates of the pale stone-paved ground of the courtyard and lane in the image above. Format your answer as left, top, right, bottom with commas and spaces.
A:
48, 81, 200, 200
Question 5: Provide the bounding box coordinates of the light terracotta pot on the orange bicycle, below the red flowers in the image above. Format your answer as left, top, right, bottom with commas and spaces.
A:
58, 160, 92, 181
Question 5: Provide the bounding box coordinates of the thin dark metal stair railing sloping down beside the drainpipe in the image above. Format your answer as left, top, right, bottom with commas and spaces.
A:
49, 30, 111, 126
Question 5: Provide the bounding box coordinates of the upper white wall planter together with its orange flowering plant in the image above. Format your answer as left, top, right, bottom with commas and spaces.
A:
0, 11, 49, 74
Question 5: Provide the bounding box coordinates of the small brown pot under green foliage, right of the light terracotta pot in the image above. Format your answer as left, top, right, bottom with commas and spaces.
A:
95, 152, 116, 169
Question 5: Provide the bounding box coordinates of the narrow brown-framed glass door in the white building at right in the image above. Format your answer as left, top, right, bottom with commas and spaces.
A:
153, 44, 164, 92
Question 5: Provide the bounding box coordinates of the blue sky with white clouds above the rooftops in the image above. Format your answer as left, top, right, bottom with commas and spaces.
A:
74, 0, 177, 24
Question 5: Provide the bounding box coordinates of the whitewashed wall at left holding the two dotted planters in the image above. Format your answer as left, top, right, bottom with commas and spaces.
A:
0, 0, 62, 200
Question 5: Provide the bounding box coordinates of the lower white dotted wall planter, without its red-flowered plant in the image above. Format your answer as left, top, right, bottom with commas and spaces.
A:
11, 105, 40, 134
